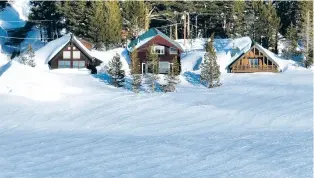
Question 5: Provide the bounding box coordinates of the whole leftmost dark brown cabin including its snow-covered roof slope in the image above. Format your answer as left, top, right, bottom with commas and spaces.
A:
36, 34, 102, 69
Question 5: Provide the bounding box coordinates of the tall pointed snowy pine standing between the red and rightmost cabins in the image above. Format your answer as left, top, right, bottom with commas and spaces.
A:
200, 33, 221, 88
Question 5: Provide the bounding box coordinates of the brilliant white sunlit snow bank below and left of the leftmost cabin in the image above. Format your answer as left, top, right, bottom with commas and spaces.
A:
0, 61, 80, 101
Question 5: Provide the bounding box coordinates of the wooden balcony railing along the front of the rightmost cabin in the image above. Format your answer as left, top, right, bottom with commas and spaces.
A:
231, 65, 278, 73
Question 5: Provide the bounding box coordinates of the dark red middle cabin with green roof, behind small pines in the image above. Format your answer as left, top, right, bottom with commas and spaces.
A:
128, 28, 184, 74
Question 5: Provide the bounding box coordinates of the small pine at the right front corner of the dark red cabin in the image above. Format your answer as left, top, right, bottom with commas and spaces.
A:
164, 57, 180, 92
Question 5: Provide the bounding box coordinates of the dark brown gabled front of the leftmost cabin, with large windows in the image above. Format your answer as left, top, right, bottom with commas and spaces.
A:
48, 34, 102, 69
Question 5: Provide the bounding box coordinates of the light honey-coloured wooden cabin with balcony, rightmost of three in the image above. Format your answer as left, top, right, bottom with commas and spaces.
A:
228, 44, 281, 73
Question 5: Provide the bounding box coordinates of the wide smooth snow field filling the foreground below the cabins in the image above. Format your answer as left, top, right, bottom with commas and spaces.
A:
0, 62, 313, 178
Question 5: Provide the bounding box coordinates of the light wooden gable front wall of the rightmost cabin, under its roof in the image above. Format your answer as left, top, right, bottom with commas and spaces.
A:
230, 47, 278, 73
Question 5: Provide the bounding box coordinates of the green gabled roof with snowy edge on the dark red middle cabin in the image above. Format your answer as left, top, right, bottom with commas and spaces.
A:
127, 28, 184, 52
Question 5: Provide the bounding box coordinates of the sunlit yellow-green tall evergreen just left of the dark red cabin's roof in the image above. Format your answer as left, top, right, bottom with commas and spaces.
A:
104, 1, 122, 49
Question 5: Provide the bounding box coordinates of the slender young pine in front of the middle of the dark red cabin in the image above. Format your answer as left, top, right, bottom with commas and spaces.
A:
147, 46, 159, 92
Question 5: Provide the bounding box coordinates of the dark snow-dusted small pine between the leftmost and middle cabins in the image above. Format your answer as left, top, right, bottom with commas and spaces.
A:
108, 53, 125, 87
